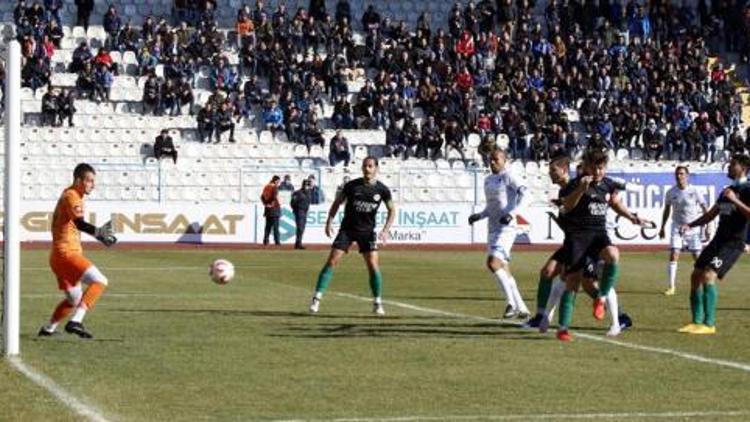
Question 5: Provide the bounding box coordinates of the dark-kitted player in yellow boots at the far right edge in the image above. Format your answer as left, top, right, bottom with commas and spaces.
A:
679, 154, 750, 334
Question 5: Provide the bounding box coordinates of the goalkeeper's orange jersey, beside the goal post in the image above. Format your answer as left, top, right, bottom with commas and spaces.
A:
52, 186, 83, 255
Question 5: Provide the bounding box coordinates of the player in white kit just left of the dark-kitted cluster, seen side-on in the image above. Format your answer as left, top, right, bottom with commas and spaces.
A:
469, 149, 529, 318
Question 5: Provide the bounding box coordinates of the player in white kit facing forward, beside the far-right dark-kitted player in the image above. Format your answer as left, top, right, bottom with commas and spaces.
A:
659, 166, 708, 296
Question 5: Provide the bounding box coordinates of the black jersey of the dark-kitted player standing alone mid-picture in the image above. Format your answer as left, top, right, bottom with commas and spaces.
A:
341, 177, 391, 233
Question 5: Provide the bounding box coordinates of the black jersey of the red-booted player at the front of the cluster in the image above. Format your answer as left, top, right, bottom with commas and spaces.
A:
560, 176, 623, 232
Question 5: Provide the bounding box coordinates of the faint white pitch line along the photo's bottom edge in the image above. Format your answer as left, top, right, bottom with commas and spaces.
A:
275, 411, 750, 422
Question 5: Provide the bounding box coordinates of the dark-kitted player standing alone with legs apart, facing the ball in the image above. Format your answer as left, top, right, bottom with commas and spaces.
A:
310, 157, 396, 315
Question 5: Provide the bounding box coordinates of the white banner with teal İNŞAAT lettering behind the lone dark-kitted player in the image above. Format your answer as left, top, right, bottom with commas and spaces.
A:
262, 203, 472, 244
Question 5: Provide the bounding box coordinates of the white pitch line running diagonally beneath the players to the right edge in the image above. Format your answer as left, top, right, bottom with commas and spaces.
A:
332, 292, 750, 372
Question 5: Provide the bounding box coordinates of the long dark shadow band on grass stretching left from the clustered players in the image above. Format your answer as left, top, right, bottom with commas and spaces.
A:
270, 322, 546, 340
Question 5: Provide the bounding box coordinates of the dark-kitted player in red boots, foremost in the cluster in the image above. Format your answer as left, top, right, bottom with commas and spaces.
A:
557, 151, 646, 341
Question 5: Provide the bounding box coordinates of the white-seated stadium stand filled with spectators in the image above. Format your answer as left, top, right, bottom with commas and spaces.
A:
0, 0, 748, 202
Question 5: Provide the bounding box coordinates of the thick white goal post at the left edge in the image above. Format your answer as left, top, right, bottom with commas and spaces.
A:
3, 40, 21, 356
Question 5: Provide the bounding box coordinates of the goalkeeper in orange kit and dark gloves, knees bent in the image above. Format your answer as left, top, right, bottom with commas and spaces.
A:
39, 163, 117, 338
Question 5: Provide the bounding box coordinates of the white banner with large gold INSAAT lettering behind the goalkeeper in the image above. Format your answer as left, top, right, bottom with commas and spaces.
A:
3, 201, 255, 243
